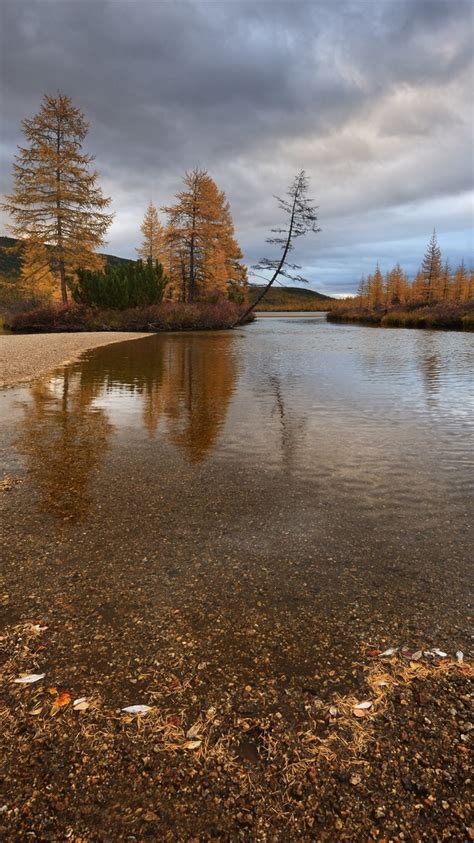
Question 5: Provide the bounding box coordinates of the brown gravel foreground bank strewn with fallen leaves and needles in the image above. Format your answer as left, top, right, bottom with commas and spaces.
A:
0, 614, 474, 843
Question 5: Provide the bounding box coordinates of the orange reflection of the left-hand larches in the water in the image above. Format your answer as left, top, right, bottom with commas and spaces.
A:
17, 334, 237, 521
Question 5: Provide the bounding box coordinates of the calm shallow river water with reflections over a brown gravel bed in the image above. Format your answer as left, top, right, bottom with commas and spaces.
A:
0, 315, 474, 695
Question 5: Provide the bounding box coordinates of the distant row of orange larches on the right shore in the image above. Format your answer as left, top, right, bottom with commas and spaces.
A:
354, 231, 474, 310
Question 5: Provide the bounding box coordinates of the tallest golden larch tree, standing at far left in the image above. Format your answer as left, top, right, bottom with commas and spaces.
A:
3, 93, 113, 304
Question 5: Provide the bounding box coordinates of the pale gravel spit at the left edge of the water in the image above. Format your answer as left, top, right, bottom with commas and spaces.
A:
0, 331, 150, 387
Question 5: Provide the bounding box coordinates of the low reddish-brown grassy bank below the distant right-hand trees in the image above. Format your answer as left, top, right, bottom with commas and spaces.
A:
327, 301, 474, 331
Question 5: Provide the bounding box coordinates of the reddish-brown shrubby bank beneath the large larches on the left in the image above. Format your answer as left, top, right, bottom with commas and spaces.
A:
5, 300, 254, 333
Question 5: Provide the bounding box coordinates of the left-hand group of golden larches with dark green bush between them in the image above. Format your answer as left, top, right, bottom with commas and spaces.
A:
3, 93, 247, 308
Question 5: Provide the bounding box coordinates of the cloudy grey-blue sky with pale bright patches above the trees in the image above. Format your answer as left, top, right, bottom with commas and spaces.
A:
0, 0, 474, 295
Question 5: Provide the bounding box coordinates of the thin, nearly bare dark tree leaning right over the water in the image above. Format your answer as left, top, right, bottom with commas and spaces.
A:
234, 170, 321, 327
